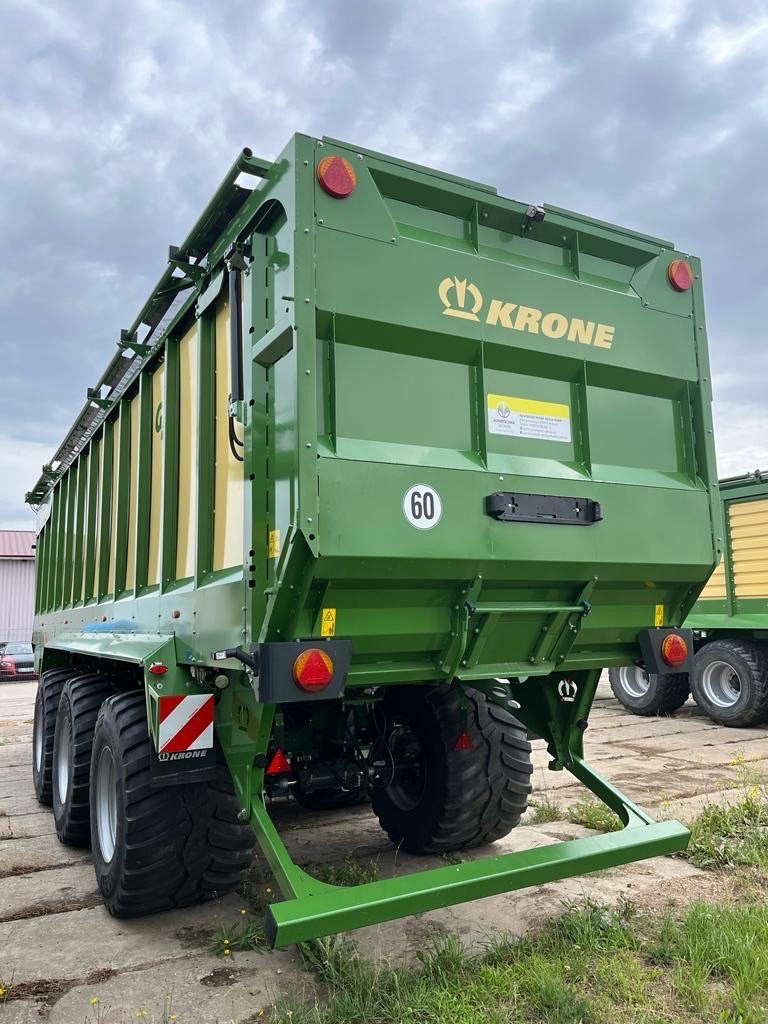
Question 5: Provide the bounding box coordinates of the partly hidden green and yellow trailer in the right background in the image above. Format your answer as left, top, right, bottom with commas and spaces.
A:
609, 470, 768, 726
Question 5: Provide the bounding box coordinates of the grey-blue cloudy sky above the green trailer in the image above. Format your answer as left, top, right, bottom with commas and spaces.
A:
0, 0, 768, 527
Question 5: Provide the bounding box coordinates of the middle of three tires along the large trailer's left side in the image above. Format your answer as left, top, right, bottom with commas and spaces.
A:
51, 675, 115, 846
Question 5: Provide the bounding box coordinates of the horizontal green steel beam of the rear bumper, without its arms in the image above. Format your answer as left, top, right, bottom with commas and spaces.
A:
267, 821, 690, 948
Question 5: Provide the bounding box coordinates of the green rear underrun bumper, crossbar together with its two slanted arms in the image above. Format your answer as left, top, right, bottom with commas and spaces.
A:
251, 753, 690, 947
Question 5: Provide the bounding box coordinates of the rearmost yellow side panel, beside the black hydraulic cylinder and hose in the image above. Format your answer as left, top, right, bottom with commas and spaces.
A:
213, 297, 245, 569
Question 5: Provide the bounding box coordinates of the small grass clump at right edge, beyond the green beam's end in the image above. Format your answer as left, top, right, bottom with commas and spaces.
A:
686, 785, 768, 871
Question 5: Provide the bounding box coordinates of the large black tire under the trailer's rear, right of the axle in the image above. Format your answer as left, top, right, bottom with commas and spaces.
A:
372, 686, 532, 854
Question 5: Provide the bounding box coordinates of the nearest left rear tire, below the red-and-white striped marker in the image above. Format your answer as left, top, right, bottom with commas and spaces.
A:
91, 691, 254, 918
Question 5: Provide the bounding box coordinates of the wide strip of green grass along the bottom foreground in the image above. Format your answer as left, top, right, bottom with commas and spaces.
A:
270, 901, 768, 1024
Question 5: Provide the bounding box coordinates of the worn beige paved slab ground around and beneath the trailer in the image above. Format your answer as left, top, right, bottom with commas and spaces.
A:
0, 683, 768, 1024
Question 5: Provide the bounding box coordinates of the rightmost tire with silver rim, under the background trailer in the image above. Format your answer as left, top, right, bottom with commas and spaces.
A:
691, 640, 768, 727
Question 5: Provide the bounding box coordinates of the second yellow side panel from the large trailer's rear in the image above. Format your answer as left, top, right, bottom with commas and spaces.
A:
176, 323, 199, 580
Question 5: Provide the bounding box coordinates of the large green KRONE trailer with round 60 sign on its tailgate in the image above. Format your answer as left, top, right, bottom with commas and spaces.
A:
28, 135, 722, 946
